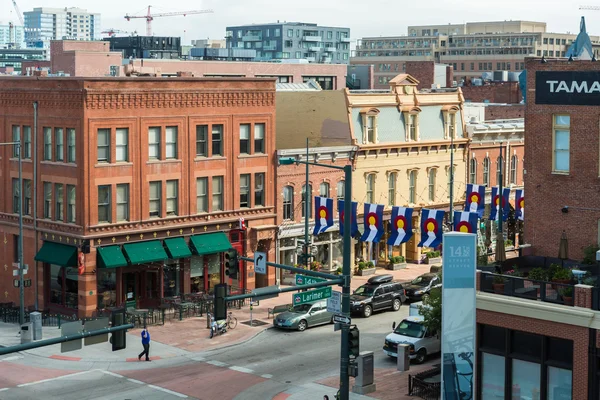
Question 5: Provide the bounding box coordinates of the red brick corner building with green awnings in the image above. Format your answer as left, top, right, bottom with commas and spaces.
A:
0, 78, 276, 316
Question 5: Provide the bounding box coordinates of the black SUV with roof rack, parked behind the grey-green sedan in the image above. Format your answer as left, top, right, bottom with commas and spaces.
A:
350, 275, 406, 318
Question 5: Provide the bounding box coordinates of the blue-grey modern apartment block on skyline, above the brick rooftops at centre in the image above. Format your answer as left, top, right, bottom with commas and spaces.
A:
225, 21, 350, 64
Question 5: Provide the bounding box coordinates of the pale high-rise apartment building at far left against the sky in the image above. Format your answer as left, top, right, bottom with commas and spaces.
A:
23, 7, 101, 48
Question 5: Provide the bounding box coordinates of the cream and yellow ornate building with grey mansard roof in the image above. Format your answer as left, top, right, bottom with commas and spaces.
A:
346, 74, 469, 265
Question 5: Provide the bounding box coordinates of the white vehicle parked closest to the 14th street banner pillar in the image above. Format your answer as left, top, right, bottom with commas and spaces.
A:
383, 316, 441, 364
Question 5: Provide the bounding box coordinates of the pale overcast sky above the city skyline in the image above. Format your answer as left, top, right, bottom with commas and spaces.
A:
0, 0, 600, 43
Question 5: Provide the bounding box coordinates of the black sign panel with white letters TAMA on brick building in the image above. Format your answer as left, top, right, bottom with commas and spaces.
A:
535, 71, 600, 106
